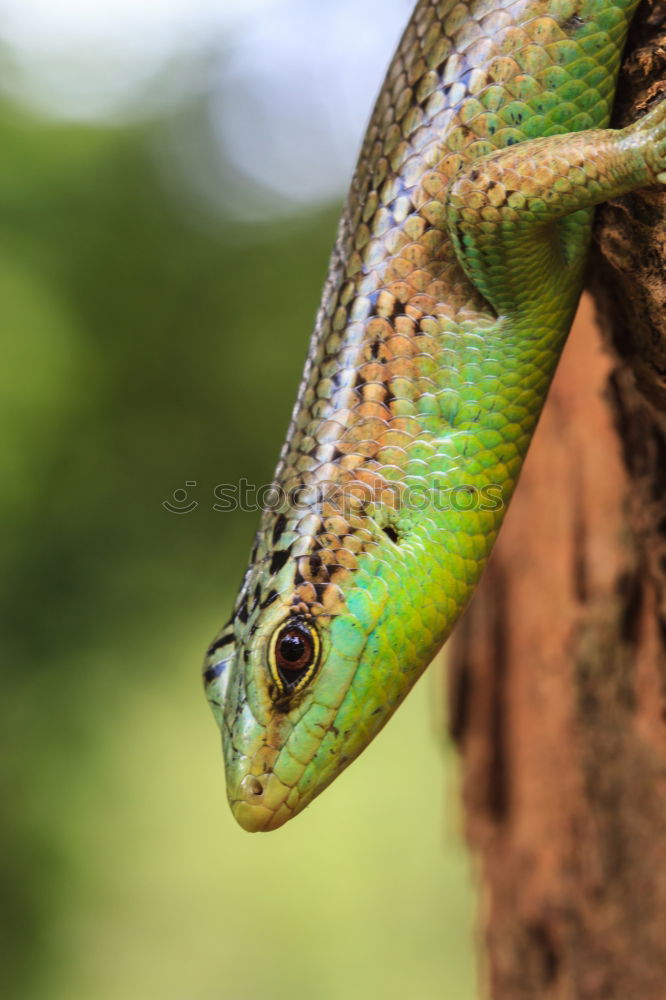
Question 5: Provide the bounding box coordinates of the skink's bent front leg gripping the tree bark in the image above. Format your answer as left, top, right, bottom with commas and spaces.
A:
446, 101, 666, 320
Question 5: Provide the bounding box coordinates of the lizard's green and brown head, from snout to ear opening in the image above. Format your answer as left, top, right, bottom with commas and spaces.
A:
204, 500, 442, 831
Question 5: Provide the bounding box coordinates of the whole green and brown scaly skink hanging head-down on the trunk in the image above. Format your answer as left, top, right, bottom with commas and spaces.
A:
204, 0, 666, 831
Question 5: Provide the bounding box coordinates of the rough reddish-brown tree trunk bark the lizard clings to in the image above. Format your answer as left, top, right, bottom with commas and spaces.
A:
450, 2, 666, 1000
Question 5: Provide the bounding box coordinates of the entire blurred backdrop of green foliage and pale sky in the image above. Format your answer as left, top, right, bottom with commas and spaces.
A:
0, 0, 477, 1000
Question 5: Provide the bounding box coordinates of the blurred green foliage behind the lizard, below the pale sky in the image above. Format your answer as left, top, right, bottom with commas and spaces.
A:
0, 90, 473, 1000
